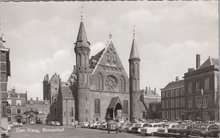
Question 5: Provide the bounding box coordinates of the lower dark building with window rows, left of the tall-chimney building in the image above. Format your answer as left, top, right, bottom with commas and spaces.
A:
161, 77, 185, 121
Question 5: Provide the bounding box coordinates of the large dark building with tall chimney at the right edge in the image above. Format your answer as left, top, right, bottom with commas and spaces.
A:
184, 55, 219, 120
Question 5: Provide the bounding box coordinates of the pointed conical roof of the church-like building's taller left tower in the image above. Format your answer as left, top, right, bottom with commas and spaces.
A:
76, 21, 90, 47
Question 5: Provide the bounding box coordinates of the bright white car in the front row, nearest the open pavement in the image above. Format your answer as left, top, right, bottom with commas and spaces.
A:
141, 123, 163, 135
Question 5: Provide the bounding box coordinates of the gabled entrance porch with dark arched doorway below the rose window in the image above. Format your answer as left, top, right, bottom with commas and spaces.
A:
105, 97, 122, 120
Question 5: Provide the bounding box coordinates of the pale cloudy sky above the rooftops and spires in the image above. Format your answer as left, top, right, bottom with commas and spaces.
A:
0, 1, 218, 99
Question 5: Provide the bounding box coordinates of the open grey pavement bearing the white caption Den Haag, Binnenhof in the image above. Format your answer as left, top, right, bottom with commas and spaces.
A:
10, 125, 161, 138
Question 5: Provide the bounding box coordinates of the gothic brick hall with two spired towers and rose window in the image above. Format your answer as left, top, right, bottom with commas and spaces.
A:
43, 21, 146, 124
